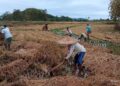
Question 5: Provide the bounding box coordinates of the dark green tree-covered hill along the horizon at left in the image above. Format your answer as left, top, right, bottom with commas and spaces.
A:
0, 8, 88, 21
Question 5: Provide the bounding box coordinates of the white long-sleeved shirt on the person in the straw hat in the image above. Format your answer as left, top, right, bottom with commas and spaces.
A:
66, 43, 86, 59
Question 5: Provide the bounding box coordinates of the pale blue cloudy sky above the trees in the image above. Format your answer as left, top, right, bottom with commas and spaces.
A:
0, 0, 110, 19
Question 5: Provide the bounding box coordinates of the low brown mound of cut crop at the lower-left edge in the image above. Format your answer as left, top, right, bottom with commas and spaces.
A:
0, 59, 31, 81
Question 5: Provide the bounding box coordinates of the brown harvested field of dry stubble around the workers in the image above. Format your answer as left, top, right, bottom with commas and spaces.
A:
0, 22, 120, 86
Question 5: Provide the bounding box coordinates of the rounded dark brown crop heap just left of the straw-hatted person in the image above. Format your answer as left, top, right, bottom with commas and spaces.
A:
36, 42, 66, 67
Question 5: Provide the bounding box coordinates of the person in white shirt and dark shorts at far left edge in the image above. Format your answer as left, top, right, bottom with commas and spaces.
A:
1, 25, 12, 50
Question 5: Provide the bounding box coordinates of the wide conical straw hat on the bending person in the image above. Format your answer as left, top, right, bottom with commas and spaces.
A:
57, 36, 78, 45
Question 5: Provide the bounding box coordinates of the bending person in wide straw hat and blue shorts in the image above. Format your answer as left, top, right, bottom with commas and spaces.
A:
58, 37, 86, 76
